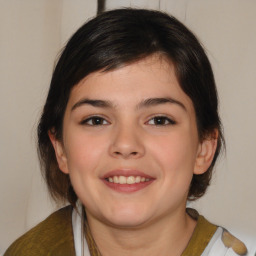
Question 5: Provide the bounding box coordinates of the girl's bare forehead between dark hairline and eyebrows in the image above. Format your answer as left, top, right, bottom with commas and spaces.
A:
68, 55, 192, 112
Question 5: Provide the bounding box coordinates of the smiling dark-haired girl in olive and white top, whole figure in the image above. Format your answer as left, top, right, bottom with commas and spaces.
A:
5, 9, 247, 256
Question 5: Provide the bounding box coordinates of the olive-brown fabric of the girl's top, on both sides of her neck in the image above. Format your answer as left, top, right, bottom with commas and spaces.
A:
4, 206, 217, 256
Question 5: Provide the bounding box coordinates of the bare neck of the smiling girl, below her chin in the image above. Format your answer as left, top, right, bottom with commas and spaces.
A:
87, 209, 196, 256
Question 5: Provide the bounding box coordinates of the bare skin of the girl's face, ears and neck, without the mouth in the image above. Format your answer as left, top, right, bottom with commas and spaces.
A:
50, 56, 216, 256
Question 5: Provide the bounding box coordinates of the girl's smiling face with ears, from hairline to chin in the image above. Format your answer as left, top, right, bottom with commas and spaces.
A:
51, 56, 215, 227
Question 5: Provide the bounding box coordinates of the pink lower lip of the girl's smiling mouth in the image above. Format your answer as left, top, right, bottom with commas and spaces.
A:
103, 179, 154, 193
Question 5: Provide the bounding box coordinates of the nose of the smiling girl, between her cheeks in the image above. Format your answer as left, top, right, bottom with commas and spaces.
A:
110, 125, 145, 159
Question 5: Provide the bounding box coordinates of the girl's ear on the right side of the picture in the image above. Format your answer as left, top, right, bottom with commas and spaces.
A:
194, 130, 218, 174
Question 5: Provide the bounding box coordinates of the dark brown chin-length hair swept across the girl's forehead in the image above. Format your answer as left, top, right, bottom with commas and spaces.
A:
38, 9, 224, 205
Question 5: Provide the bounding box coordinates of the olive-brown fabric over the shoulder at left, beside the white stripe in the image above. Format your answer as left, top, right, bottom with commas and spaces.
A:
4, 206, 75, 256
